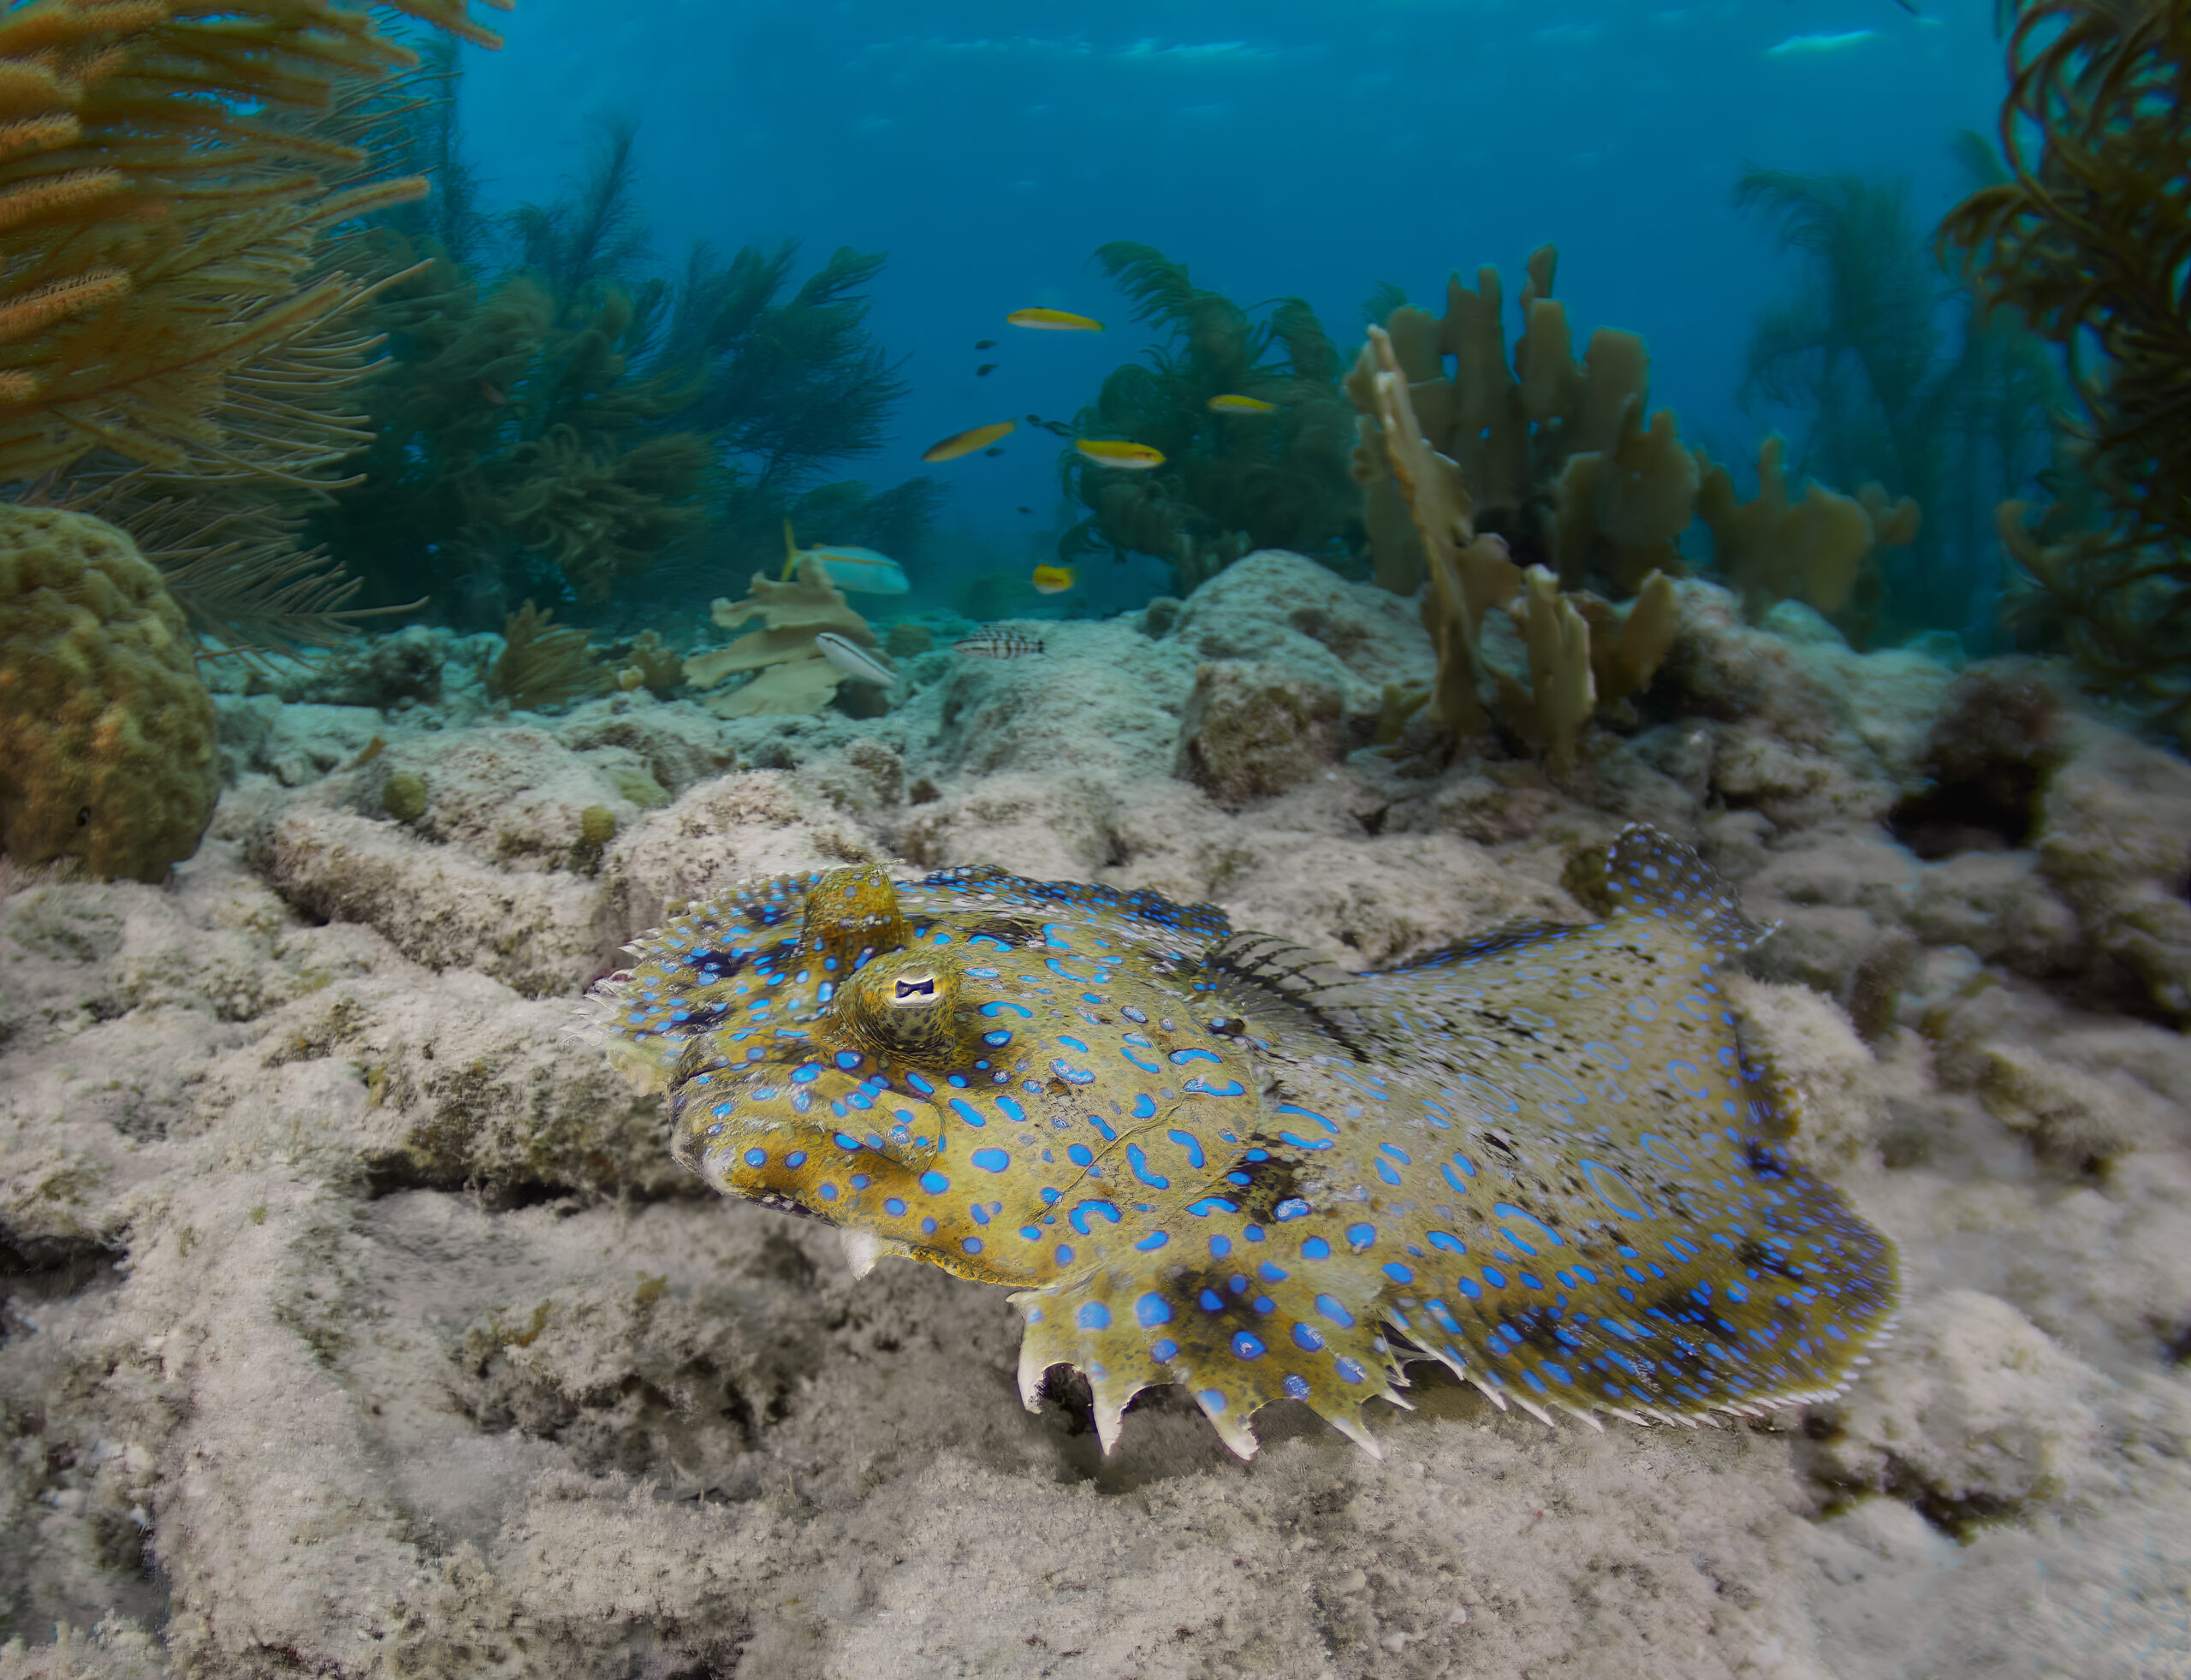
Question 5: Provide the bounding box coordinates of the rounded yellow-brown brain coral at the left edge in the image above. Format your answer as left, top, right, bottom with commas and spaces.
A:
0, 506, 219, 881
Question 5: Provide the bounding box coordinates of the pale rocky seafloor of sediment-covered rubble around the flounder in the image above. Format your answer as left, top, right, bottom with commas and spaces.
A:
0, 555, 2191, 1680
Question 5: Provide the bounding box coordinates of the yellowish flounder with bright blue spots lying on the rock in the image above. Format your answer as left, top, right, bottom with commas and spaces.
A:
590, 828, 1895, 1457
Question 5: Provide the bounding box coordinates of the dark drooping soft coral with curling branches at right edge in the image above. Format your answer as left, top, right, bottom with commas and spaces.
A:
1941, 0, 2191, 740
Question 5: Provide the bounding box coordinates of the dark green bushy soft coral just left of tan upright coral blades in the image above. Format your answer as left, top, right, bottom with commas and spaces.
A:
1058, 241, 1358, 594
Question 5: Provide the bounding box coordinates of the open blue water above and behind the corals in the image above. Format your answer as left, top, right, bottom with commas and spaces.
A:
462, 0, 2003, 613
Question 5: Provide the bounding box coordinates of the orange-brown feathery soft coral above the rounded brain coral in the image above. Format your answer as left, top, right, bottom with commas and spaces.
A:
0, 0, 510, 692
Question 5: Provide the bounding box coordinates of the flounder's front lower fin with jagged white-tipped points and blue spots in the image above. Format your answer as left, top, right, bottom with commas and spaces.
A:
1012, 1242, 1407, 1459
